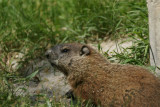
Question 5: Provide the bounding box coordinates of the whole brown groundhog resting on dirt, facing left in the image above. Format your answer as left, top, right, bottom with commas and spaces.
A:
45, 43, 160, 107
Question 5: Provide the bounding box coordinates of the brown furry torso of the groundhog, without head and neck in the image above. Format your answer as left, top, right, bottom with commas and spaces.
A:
75, 64, 160, 107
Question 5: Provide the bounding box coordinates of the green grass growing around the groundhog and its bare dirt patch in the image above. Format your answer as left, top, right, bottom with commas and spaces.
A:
0, 0, 149, 107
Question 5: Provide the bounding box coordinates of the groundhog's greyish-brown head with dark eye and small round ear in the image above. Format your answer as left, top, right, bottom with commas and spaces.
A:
45, 43, 93, 75
